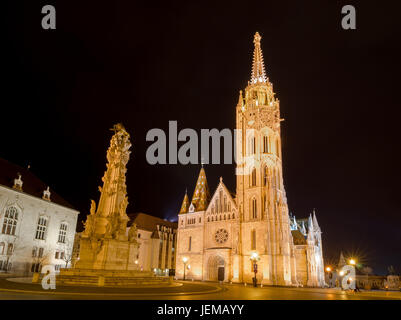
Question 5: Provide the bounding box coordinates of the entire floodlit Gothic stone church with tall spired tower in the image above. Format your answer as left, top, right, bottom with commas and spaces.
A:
176, 33, 325, 286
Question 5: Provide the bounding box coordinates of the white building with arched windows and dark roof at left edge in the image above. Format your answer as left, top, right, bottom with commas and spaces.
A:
0, 159, 79, 274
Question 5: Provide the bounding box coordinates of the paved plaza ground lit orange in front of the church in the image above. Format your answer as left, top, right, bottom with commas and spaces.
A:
0, 278, 401, 300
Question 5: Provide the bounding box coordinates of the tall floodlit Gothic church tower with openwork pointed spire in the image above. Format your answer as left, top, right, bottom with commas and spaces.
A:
236, 33, 295, 285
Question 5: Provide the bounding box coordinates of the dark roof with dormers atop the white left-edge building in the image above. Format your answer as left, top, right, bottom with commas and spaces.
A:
0, 158, 76, 210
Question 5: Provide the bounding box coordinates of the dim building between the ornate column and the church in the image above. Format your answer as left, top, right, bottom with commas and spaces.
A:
128, 213, 177, 275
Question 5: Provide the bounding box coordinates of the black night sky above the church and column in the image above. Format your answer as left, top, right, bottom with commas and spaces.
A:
0, 0, 401, 273
